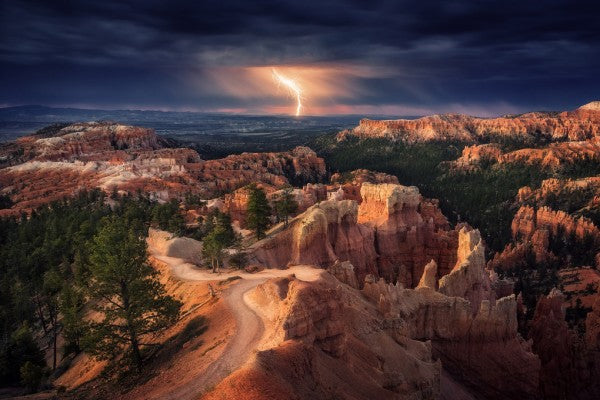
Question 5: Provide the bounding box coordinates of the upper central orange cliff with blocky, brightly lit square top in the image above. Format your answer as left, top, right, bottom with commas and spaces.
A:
252, 183, 458, 287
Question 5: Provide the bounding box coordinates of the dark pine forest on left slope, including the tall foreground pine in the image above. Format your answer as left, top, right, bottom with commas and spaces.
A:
0, 190, 184, 389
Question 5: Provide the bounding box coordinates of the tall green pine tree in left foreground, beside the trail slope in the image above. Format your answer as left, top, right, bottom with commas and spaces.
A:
84, 216, 181, 371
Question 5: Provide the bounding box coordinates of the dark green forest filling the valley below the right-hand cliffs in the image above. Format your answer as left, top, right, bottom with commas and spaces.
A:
312, 135, 600, 251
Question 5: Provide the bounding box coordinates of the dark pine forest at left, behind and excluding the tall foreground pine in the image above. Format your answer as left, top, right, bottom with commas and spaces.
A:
0, 190, 192, 389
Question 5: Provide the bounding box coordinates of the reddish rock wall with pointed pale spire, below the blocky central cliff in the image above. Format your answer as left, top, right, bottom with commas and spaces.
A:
362, 239, 540, 399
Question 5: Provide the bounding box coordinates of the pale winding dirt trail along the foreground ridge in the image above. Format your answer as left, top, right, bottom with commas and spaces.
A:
150, 249, 323, 400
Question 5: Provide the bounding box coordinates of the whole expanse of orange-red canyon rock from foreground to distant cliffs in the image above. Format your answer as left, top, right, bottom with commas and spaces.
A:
0, 104, 600, 400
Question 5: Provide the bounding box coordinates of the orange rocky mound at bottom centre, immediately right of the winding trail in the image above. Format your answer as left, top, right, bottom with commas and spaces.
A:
229, 273, 441, 400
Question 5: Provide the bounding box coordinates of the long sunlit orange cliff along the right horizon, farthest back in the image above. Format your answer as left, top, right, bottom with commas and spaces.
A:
338, 106, 600, 143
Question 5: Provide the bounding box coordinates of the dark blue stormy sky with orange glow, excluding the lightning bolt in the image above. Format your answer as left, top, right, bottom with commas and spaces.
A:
0, 0, 600, 116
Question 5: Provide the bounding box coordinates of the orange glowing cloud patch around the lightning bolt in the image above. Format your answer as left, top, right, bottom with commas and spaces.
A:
189, 64, 389, 115
